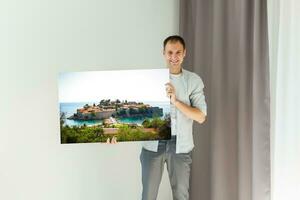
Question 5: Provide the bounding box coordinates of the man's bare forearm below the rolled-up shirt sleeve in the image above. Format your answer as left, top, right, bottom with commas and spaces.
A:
174, 100, 205, 124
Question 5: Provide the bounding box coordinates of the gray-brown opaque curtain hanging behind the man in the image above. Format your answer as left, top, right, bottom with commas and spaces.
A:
180, 0, 270, 200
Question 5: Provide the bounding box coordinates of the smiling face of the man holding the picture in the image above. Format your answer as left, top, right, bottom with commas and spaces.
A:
164, 41, 186, 68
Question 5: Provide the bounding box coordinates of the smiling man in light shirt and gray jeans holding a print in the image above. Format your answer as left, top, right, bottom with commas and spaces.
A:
140, 35, 206, 200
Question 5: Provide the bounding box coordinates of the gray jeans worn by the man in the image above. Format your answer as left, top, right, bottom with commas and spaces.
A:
140, 136, 192, 200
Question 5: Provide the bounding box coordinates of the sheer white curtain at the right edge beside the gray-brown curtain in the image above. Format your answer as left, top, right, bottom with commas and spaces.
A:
268, 0, 300, 200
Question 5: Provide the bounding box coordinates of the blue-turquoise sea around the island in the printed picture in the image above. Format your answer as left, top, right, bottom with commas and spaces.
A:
59, 102, 170, 126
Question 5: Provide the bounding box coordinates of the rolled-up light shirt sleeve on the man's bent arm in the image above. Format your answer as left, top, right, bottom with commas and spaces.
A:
190, 75, 207, 115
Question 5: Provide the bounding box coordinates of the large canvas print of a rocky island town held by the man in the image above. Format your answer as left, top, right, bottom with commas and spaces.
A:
58, 69, 171, 144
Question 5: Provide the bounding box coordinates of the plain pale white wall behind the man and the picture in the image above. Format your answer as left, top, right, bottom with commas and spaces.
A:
0, 0, 179, 200
